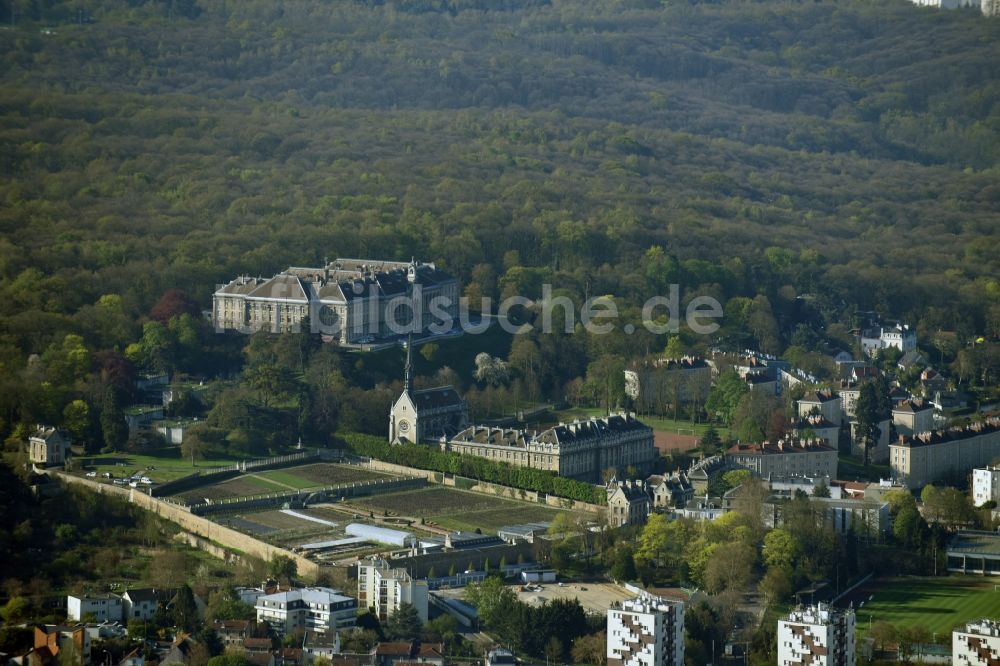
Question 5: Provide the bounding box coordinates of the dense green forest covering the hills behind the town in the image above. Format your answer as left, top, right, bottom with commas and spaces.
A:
0, 0, 1000, 439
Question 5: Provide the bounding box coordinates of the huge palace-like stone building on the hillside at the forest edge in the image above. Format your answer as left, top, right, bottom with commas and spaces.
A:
212, 259, 459, 344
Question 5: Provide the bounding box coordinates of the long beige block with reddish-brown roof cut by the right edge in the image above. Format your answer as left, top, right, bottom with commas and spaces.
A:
889, 416, 1000, 488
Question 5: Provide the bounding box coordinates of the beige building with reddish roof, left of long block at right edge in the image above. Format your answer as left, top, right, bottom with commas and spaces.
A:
726, 439, 837, 479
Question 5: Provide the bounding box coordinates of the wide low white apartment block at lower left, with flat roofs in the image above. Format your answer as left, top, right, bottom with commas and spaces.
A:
254, 587, 358, 635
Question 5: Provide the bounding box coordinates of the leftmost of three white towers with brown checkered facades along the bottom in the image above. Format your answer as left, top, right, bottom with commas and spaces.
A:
608, 593, 684, 666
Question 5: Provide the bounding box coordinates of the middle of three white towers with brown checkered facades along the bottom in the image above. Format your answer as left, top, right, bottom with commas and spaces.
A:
778, 604, 856, 666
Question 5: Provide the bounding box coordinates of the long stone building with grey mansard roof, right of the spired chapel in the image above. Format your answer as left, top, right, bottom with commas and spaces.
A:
441, 413, 659, 482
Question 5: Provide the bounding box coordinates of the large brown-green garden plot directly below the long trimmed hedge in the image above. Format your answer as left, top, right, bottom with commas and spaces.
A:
351, 488, 560, 533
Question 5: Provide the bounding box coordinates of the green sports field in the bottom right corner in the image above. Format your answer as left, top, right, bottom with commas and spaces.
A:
838, 574, 1000, 637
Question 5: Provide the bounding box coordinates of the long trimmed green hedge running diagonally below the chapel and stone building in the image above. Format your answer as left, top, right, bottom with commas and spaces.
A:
340, 432, 607, 505
